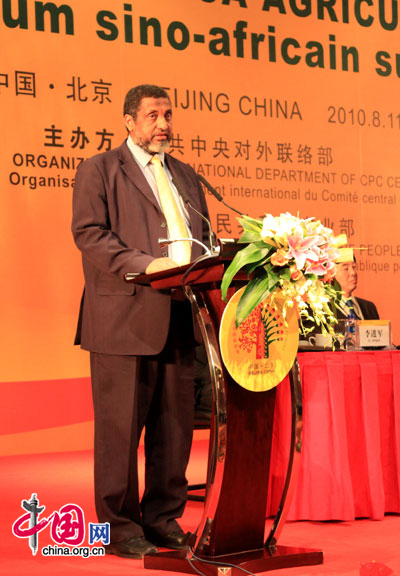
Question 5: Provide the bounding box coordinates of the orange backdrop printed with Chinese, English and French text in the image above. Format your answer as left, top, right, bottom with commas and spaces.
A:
0, 0, 400, 396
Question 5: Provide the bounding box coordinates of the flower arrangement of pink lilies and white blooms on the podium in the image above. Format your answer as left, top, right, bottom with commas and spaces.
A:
221, 212, 346, 334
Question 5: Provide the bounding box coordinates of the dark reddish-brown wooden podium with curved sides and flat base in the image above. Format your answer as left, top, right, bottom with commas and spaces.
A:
126, 241, 323, 576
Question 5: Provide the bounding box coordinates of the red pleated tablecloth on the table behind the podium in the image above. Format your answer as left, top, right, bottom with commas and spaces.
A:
267, 351, 400, 520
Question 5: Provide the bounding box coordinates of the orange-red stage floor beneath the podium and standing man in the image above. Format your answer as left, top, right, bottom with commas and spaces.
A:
0, 439, 400, 576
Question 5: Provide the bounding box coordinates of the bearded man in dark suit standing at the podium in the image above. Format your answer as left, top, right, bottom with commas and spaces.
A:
72, 85, 207, 558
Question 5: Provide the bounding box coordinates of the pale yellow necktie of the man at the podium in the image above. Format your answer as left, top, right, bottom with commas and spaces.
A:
151, 156, 191, 266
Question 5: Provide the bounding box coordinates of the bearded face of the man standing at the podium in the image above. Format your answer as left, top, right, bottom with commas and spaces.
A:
125, 98, 172, 154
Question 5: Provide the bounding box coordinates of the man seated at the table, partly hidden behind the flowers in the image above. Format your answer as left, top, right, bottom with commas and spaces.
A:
336, 260, 379, 320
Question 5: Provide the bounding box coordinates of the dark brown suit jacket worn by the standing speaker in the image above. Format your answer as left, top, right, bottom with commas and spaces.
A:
72, 142, 208, 355
